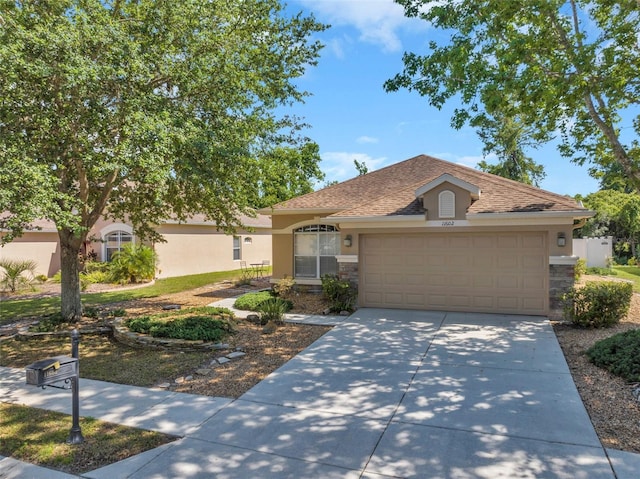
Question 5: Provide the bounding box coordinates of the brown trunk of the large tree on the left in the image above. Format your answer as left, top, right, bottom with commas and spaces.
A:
58, 230, 83, 322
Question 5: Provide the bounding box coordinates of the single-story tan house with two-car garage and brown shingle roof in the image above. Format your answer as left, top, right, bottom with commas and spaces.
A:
260, 155, 593, 316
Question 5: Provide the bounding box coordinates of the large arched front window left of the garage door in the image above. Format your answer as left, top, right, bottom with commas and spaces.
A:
293, 225, 340, 279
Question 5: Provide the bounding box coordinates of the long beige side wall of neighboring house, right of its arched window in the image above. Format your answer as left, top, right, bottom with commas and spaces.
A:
155, 225, 271, 278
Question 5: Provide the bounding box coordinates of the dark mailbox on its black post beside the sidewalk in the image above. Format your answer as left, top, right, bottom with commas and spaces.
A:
26, 329, 84, 444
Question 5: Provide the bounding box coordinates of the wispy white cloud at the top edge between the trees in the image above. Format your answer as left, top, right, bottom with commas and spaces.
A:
297, 0, 426, 52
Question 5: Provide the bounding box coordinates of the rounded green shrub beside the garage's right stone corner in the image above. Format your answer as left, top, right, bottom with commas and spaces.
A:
563, 281, 633, 328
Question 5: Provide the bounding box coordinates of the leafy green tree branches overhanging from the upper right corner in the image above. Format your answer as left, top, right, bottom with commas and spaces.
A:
385, 0, 640, 191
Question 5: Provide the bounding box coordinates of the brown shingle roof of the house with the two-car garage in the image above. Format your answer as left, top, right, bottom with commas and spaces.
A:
273, 155, 587, 217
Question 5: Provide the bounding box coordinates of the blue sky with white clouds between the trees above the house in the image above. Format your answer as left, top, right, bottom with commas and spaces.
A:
282, 0, 598, 195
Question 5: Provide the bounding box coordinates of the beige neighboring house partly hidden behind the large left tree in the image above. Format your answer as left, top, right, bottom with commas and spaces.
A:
0, 215, 271, 278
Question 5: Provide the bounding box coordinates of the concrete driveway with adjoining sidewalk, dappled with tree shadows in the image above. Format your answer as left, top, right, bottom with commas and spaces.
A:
0, 309, 640, 479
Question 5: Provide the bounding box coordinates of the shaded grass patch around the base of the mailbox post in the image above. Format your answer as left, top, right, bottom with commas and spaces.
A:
0, 403, 177, 474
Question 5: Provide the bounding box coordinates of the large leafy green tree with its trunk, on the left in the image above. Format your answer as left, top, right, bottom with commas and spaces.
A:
0, 0, 325, 318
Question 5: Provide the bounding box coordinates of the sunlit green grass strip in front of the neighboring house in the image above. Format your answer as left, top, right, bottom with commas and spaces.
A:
0, 270, 241, 325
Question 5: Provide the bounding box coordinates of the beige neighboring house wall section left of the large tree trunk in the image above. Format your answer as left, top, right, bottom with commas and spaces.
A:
0, 232, 60, 276
